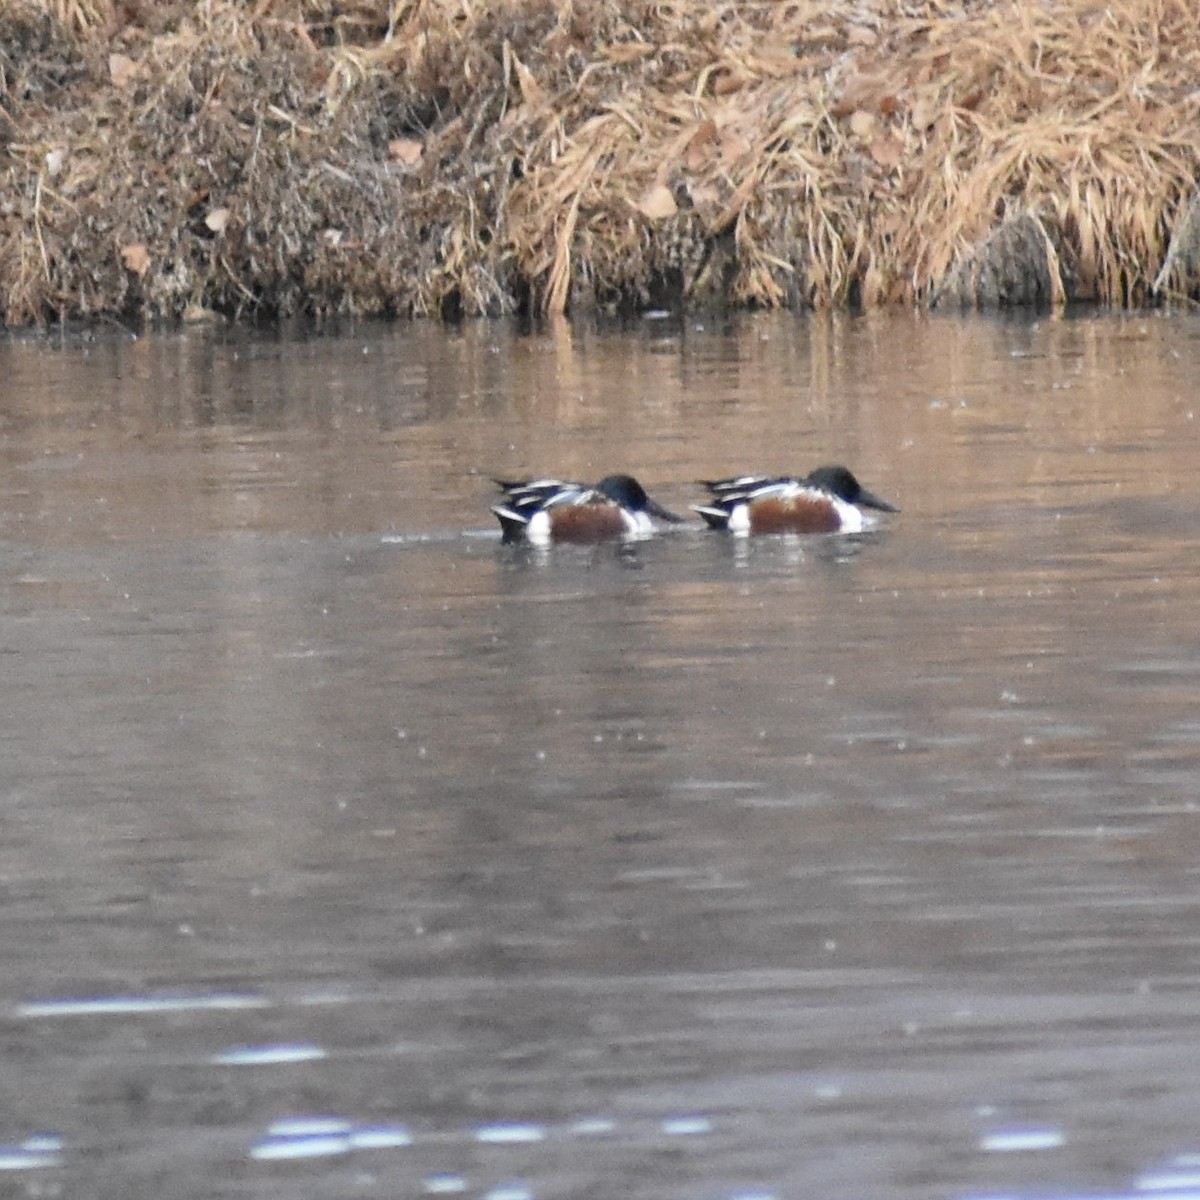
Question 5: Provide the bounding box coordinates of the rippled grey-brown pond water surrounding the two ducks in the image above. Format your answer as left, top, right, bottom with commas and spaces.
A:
0, 316, 1200, 1200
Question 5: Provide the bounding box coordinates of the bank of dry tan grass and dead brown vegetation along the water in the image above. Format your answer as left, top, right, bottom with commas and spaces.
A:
0, 0, 1200, 324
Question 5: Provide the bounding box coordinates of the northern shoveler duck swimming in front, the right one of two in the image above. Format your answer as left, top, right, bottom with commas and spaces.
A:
692, 467, 900, 534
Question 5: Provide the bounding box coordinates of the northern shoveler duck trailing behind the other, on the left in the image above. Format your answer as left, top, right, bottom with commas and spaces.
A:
492, 475, 683, 542
